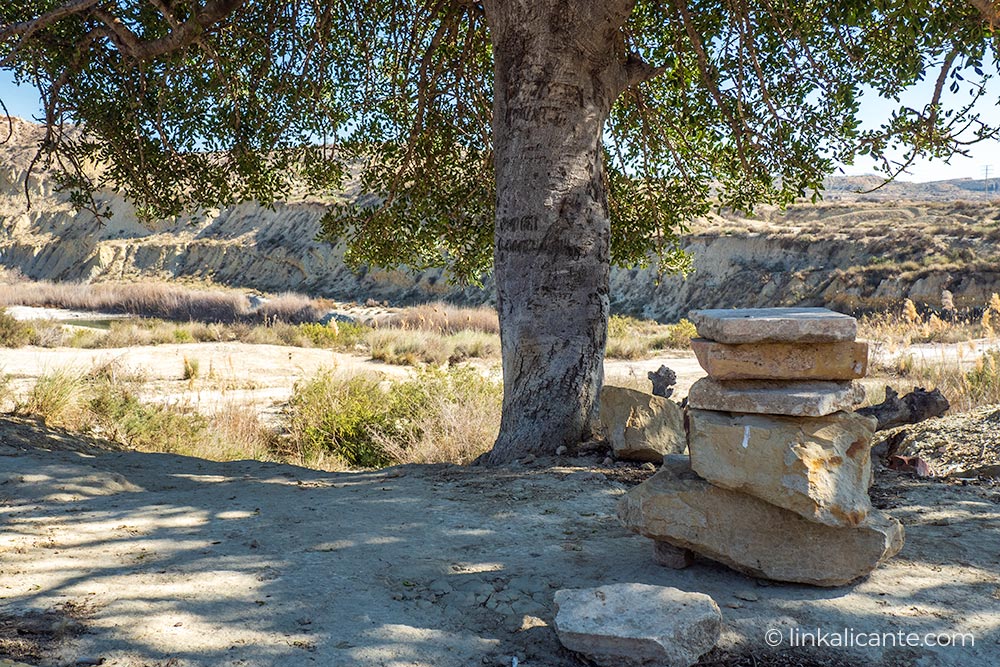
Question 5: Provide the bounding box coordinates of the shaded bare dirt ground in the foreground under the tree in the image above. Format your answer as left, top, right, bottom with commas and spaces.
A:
0, 421, 1000, 667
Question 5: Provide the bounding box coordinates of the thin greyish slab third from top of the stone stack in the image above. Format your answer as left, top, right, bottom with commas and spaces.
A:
688, 378, 865, 417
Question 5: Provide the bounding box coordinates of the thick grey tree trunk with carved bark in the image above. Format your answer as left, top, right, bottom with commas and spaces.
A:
486, 0, 631, 464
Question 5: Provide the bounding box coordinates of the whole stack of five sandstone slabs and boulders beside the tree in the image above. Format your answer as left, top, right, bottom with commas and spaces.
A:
619, 308, 903, 586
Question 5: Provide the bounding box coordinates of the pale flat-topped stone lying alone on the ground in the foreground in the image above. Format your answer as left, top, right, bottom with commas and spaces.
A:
555, 584, 722, 667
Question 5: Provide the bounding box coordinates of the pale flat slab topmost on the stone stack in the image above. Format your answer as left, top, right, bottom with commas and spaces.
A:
688, 308, 858, 345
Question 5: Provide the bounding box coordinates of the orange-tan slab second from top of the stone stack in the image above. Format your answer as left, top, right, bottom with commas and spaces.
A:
691, 338, 868, 380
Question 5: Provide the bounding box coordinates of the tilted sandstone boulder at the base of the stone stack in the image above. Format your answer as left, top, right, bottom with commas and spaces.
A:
618, 456, 903, 586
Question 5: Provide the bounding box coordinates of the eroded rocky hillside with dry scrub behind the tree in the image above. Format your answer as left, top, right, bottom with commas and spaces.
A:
0, 121, 1000, 321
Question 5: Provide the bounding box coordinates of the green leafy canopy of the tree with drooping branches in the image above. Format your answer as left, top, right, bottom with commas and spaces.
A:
0, 0, 998, 278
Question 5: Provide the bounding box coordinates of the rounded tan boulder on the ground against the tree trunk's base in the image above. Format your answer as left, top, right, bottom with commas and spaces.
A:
601, 386, 687, 463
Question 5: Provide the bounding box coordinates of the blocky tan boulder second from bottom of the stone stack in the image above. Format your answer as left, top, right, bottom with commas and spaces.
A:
688, 410, 876, 526
